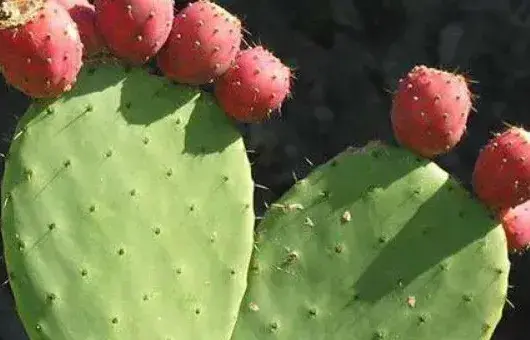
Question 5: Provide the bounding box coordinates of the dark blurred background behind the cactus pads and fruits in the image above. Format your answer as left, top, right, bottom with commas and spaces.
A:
0, 0, 530, 340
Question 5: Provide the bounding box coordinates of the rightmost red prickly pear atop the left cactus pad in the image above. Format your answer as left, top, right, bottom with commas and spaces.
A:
215, 46, 291, 122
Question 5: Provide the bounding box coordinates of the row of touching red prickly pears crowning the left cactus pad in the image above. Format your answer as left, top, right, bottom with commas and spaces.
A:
0, 0, 292, 122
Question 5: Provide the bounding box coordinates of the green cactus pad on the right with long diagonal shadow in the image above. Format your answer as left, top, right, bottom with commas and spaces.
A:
232, 143, 509, 340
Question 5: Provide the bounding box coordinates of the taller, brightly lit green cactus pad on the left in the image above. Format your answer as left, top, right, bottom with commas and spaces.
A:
2, 66, 254, 340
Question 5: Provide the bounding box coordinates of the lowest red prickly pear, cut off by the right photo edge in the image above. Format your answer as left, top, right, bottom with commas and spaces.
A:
499, 201, 530, 252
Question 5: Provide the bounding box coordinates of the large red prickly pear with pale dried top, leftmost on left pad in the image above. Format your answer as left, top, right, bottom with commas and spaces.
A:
0, 0, 83, 98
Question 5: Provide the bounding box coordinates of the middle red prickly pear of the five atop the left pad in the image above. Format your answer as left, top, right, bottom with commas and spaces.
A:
94, 0, 173, 65
